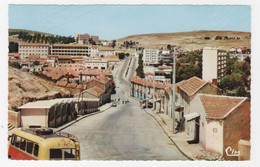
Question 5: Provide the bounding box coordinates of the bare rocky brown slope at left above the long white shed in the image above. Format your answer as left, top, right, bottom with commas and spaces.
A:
8, 67, 70, 109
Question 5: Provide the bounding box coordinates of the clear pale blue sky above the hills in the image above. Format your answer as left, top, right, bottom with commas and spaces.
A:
9, 5, 251, 40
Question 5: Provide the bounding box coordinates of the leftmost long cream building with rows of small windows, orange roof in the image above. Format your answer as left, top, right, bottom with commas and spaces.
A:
18, 43, 50, 59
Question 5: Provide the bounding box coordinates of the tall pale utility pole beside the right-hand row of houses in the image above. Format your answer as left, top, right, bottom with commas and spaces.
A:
172, 46, 176, 133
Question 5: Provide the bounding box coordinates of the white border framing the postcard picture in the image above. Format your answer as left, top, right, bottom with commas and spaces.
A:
0, 0, 260, 167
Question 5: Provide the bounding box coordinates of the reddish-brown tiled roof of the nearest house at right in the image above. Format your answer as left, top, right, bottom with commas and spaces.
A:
199, 94, 247, 119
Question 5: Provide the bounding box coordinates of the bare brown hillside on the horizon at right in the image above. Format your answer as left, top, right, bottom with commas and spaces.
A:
116, 31, 251, 50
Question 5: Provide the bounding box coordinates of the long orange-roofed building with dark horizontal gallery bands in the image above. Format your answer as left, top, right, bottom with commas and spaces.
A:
50, 44, 89, 56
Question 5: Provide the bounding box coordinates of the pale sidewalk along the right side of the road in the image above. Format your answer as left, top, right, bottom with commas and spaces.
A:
145, 109, 223, 160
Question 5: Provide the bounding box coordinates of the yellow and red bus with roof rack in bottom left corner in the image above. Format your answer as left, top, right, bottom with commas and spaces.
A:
8, 127, 80, 160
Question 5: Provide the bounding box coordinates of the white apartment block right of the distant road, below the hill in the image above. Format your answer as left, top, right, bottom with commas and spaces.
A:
143, 49, 159, 65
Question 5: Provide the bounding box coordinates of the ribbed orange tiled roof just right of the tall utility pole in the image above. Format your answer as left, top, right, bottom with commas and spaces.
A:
178, 76, 208, 96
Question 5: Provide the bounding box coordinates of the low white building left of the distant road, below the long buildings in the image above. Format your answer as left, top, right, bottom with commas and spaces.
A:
83, 58, 108, 70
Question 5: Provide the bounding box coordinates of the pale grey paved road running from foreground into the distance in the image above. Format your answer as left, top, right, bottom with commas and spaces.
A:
64, 57, 187, 160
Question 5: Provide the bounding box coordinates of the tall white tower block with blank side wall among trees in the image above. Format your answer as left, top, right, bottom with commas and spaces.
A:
202, 47, 227, 84
